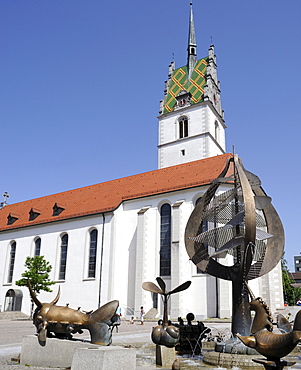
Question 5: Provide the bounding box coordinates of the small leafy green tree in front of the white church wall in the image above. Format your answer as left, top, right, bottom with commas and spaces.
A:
16, 256, 55, 294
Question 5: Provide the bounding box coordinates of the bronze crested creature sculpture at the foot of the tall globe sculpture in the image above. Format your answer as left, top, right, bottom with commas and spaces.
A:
236, 285, 301, 362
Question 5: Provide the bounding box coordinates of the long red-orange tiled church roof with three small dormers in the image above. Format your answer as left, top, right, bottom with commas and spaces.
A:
0, 153, 232, 232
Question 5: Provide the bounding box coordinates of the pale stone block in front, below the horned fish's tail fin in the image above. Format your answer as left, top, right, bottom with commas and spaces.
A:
71, 346, 136, 370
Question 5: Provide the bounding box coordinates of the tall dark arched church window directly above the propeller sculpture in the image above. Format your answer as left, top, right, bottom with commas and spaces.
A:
160, 203, 171, 276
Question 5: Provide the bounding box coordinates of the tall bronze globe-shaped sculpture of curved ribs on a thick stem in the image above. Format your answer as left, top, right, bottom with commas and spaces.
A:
185, 155, 284, 335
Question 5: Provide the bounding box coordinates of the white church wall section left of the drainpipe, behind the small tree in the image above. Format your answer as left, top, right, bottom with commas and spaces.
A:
0, 217, 108, 314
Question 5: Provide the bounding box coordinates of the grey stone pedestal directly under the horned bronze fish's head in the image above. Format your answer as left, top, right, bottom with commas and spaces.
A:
20, 335, 99, 368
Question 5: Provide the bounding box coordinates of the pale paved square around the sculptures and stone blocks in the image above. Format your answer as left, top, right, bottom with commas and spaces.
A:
0, 320, 229, 370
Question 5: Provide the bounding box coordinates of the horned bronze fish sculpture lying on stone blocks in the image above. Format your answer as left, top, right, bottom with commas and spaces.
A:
28, 283, 120, 346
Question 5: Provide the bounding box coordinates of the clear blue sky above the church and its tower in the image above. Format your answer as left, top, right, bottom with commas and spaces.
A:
0, 0, 301, 270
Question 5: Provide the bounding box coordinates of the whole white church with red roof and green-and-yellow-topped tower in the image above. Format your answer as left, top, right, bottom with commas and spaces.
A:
0, 5, 283, 320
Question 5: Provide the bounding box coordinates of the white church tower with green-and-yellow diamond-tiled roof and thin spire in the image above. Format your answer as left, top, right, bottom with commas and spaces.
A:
158, 3, 226, 168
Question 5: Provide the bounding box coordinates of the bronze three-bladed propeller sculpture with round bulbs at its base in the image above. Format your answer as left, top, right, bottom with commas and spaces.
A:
142, 277, 191, 348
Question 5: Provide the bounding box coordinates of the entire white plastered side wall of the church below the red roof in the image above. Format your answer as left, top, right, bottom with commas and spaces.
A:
0, 186, 283, 319
